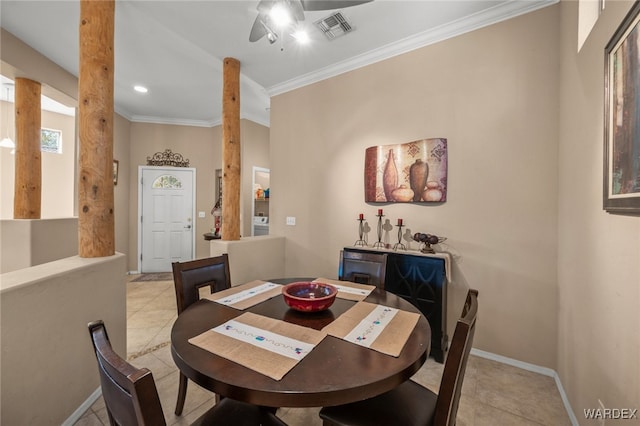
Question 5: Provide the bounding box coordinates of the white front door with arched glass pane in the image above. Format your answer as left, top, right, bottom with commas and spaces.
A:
138, 166, 195, 272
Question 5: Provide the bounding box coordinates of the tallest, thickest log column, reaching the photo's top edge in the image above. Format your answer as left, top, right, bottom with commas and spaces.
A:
78, 0, 115, 257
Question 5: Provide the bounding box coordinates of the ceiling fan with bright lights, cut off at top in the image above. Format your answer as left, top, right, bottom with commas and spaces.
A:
249, 0, 373, 44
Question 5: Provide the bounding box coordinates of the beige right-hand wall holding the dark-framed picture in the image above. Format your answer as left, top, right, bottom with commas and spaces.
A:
556, 1, 640, 418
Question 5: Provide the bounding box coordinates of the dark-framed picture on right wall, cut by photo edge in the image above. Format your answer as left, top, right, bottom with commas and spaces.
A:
603, 1, 640, 214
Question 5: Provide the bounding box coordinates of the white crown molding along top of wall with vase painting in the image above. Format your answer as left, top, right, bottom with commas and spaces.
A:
267, 0, 560, 96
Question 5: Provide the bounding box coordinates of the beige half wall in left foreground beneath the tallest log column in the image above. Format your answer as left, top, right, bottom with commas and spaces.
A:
0, 253, 127, 425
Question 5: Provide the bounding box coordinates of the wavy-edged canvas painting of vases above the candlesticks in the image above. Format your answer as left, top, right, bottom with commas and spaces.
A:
364, 138, 447, 203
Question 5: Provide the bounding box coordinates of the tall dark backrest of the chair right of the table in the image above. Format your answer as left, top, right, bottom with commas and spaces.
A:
433, 289, 478, 426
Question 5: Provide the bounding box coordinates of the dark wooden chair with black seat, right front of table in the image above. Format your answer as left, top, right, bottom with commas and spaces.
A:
320, 289, 478, 426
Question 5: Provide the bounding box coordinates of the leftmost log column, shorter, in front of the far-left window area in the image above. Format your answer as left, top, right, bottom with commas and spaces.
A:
13, 78, 42, 219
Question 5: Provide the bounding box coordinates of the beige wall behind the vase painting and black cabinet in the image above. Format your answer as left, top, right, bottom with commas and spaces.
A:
271, 7, 559, 368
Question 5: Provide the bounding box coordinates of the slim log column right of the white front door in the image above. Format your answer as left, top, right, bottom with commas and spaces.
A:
222, 58, 240, 241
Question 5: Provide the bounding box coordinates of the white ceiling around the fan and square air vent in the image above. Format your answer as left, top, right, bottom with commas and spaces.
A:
0, 0, 558, 126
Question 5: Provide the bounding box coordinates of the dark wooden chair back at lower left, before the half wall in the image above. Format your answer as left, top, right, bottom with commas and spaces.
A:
88, 321, 166, 426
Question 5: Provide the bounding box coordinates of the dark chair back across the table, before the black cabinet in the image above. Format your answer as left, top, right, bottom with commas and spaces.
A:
338, 250, 387, 289
